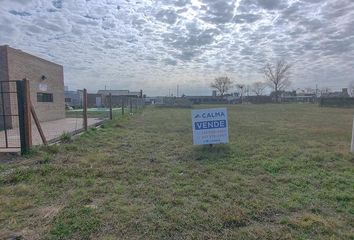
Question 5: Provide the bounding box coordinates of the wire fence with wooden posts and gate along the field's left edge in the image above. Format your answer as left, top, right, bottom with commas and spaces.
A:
0, 82, 144, 152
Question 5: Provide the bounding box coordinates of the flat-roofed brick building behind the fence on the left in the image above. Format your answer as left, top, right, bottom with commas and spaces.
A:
0, 45, 65, 128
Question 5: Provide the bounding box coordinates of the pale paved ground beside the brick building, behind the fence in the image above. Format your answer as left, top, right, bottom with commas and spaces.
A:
0, 118, 102, 152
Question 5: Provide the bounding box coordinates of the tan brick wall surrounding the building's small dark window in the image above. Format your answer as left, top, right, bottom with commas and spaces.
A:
1, 46, 65, 127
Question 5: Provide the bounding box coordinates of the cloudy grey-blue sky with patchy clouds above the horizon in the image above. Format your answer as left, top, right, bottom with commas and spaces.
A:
0, 0, 354, 95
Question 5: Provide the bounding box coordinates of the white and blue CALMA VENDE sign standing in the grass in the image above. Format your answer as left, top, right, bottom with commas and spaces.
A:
192, 108, 229, 145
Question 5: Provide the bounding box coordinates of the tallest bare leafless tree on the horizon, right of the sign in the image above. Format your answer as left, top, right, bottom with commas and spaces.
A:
264, 60, 291, 102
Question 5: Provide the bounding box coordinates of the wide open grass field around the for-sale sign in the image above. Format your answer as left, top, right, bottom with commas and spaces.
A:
0, 104, 354, 239
